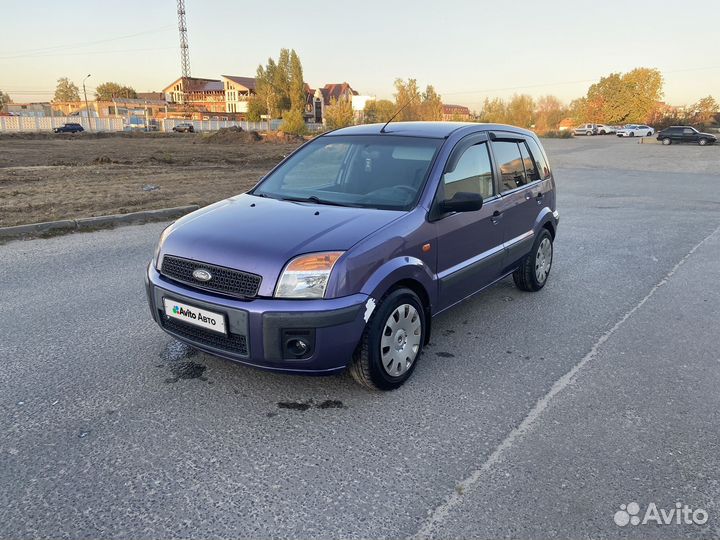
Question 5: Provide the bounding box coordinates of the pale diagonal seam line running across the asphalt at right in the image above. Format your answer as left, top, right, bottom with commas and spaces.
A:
411, 221, 720, 539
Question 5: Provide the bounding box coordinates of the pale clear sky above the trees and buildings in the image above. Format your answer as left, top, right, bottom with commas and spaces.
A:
0, 0, 720, 110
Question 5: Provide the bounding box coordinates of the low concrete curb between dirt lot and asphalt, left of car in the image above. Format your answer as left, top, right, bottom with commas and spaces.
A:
0, 204, 200, 238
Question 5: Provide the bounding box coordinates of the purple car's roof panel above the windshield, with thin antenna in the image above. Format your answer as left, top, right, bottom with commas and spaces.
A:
325, 122, 533, 139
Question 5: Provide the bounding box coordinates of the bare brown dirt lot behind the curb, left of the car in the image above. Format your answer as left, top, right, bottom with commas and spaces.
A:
0, 133, 299, 227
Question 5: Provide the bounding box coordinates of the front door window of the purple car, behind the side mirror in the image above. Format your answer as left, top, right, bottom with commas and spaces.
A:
443, 142, 495, 199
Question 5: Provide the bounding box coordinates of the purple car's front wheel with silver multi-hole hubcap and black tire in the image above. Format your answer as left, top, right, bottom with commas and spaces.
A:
349, 288, 427, 390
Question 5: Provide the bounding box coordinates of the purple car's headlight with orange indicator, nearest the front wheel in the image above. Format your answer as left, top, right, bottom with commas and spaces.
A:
275, 251, 344, 298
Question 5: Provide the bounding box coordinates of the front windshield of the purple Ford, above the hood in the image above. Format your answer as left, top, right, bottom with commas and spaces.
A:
251, 135, 443, 210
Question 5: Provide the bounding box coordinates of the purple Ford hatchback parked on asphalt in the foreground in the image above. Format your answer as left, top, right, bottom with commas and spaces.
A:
145, 122, 558, 390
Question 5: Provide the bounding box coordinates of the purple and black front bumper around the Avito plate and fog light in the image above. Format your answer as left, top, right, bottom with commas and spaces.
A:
145, 263, 368, 374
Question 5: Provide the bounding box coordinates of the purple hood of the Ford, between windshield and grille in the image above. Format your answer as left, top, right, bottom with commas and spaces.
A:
160, 195, 405, 296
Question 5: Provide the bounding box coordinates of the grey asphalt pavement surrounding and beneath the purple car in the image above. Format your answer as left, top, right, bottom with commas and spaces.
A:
0, 137, 720, 539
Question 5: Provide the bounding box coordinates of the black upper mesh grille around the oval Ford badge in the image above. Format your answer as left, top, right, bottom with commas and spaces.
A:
160, 255, 262, 298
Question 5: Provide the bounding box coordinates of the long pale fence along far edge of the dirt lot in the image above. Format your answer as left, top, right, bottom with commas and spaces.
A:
0, 116, 325, 133
